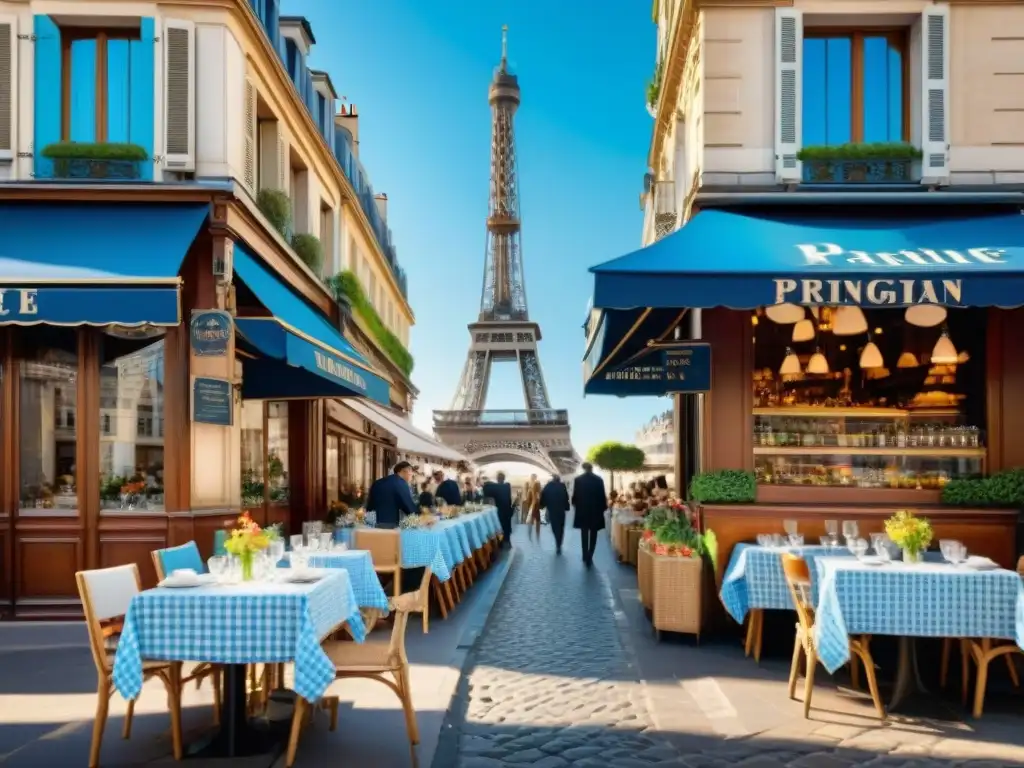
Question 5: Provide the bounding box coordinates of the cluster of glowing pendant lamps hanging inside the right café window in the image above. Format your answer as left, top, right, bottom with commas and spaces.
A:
764, 304, 966, 376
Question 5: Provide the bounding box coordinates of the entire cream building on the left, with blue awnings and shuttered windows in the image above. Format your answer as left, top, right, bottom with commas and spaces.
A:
0, 0, 457, 616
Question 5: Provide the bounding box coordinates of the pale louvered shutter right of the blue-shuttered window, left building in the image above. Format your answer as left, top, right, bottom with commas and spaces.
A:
164, 18, 196, 171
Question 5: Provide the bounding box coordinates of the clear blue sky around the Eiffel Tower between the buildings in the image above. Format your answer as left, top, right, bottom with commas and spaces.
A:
284, 0, 669, 468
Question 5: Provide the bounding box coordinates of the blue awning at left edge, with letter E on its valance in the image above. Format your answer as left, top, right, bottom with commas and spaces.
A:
0, 203, 210, 326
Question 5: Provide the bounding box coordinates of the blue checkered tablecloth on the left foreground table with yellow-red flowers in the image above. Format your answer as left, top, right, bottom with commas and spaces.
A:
114, 570, 366, 701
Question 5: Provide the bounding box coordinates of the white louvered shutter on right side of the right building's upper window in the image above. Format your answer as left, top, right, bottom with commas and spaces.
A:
921, 5, 949, 184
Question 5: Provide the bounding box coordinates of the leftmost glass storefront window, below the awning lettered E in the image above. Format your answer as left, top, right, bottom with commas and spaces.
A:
18, 327, 78, 512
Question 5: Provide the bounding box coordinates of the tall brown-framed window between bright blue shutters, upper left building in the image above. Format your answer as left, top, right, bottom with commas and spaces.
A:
60, 27, 144, 142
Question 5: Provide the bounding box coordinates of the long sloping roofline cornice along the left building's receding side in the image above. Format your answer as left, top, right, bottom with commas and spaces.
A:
165, 0, 416, 324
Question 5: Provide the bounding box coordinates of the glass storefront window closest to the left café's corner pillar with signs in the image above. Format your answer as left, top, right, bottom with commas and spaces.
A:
99, 329, 164, 511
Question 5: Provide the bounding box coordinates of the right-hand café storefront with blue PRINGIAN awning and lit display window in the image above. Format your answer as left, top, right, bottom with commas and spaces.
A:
584, 201, 1024, 598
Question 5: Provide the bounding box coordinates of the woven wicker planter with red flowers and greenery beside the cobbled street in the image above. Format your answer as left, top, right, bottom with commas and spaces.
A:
637, 502, 718, 639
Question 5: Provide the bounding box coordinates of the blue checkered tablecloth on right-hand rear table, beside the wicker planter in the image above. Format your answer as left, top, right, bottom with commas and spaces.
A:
719, 544, 851, 624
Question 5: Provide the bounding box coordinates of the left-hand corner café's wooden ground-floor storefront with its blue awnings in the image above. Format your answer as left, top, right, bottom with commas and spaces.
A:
0, 192, 391, 618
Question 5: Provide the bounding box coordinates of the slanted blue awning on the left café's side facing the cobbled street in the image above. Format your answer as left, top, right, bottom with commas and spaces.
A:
234, 245, 390, 406
